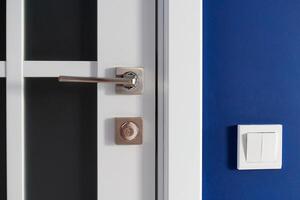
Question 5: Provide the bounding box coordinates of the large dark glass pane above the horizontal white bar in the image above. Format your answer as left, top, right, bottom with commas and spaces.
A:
25, 0, 97, 61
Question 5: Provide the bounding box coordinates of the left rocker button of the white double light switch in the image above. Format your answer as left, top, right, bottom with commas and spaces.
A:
247, 133, 262, 162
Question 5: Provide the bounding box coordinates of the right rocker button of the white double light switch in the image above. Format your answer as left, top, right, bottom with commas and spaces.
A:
262, 133, 277, 162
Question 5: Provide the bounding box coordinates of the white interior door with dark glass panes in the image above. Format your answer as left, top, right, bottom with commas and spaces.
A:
0, 0, 156, 200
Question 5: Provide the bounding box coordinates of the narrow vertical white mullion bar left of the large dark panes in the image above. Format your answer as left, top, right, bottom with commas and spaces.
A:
6, 0, 25, 200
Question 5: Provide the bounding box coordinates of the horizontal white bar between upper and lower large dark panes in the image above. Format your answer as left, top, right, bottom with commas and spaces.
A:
24, 61, 97, 77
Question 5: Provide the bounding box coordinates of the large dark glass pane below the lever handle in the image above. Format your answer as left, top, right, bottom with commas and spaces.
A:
25, 78, 97, 200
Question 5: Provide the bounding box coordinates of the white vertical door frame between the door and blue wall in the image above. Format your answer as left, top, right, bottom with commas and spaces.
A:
157, 0, 203, 200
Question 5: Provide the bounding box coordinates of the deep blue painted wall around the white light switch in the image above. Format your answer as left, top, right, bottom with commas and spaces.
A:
203, 0, 300, 200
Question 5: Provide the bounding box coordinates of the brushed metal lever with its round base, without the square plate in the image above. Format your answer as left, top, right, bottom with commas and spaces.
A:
58, 71, 138, 89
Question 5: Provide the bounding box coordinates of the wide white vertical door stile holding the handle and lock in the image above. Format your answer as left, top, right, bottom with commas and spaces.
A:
97, 0, 156, 200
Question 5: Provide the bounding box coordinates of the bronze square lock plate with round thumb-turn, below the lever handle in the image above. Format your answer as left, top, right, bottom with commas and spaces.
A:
115, 117, 143, 145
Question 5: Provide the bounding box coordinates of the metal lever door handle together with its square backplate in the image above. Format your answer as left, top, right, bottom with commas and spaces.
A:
58, 67, 144, 95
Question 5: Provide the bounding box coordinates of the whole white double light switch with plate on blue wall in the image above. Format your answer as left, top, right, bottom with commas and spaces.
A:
237, 124, 282, 170
